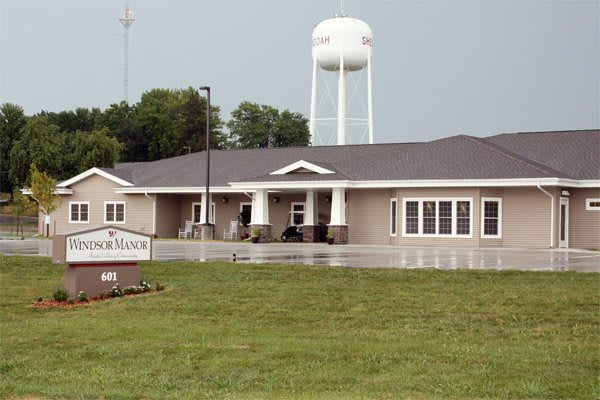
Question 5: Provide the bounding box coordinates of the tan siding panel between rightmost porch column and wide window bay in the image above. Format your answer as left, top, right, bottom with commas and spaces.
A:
347, 189, 392, 244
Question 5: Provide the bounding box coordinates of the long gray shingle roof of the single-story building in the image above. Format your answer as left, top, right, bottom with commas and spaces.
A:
104, 130, 600, 187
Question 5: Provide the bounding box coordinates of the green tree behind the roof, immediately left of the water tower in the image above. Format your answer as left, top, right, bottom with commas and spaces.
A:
227, 101, 309, 149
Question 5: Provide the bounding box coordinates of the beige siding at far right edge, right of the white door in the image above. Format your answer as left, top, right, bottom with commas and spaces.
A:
568, 188, 600, 249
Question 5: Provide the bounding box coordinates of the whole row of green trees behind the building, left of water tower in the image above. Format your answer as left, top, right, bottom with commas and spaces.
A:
0, 87, 309, 193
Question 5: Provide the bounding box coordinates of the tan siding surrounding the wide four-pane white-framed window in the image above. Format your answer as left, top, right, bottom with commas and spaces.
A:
396, 188, 480, 247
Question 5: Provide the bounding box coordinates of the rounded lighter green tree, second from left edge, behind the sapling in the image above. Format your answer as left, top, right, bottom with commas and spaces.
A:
8, 116, 63, 187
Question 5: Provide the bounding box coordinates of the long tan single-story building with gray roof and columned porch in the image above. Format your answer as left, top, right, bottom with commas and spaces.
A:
39, 130, 600, 249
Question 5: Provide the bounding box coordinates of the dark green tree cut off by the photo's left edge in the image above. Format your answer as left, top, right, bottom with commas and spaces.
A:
0, 103, 27, 193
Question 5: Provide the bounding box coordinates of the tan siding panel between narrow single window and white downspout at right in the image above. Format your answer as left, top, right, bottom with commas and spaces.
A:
502, 188, 558, 248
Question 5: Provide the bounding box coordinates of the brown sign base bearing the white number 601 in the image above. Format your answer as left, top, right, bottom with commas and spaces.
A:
65, 264, 141, 299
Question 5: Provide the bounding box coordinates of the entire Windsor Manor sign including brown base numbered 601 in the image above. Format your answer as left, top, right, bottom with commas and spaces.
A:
52, 226, 152, 298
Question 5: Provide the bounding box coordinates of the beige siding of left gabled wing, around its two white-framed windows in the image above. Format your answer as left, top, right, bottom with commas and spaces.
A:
47, 175, 153, 235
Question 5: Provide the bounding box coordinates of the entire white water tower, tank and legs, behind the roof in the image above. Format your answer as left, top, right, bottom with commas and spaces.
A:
309, 11, 373, 145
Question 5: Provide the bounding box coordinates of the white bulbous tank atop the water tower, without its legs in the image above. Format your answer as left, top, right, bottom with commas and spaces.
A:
312, 17, 373, 71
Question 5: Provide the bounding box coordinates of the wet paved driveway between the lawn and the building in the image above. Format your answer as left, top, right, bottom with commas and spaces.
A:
0, 239, 600, 272
